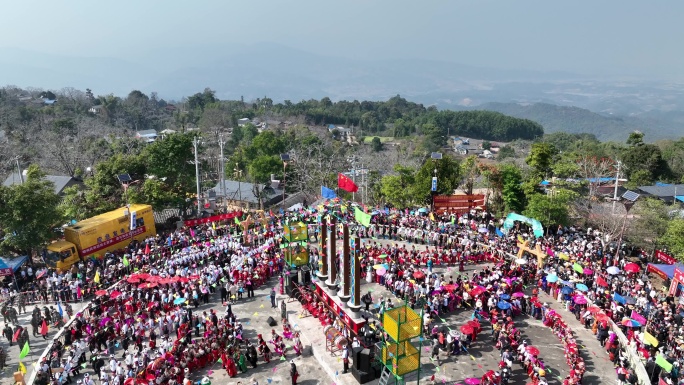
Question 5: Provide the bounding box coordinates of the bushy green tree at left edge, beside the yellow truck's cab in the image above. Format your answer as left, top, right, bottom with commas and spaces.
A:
0, 165, 61, 256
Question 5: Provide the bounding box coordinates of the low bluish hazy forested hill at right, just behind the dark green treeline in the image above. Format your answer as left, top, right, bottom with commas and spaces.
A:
475, 103, 684, 142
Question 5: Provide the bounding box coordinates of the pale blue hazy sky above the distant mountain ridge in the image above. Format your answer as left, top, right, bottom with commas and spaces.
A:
0, 0, 684, 78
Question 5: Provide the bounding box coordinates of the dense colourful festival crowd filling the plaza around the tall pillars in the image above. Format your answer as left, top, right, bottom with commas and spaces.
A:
3, 203, 684, 384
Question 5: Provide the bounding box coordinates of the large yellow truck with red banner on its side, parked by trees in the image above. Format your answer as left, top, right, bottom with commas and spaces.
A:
44, 204, 157, 271
